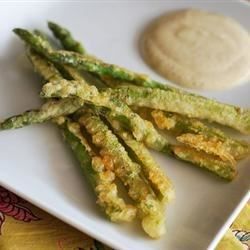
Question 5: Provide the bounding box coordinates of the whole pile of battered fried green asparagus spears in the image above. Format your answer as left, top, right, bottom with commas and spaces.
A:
0, 22, 250, 238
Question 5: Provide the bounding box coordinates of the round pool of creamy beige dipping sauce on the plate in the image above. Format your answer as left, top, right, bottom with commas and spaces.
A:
142, 9, 250, 90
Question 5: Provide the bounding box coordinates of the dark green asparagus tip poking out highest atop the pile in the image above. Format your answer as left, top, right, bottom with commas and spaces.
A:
48, 22, 85, 54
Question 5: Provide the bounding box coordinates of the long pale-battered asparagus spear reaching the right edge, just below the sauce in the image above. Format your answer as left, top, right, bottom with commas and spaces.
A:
108, 86, 250, 133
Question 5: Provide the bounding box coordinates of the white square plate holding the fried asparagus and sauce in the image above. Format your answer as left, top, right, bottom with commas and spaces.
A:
0, 0, 250, 250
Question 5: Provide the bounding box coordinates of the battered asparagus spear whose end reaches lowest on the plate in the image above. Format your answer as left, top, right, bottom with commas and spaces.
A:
79, 113, 165, 238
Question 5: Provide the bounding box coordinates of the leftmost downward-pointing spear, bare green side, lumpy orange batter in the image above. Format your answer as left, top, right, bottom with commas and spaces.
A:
56, 117, 136, 222
